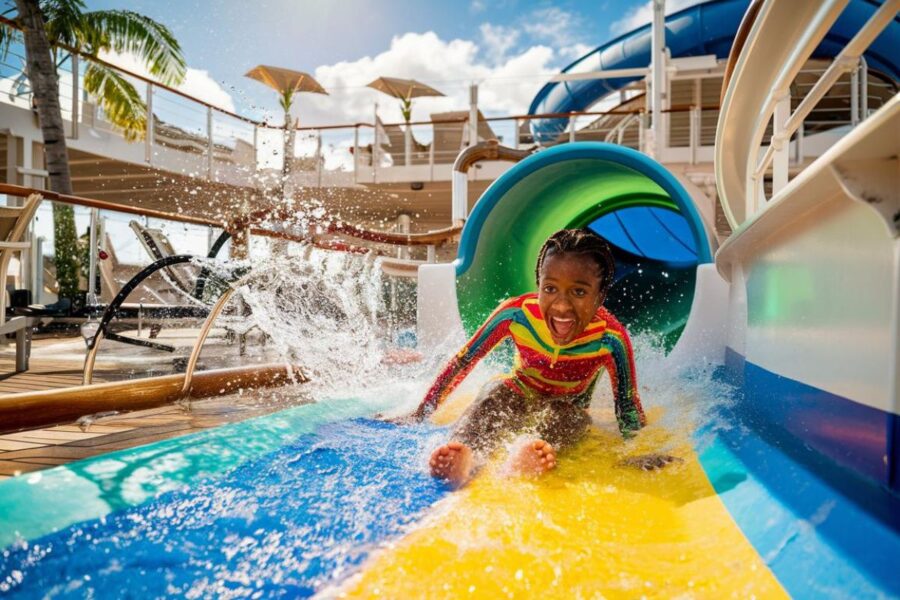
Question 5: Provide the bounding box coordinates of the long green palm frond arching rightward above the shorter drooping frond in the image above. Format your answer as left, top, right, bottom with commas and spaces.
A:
81, 9, 187, 85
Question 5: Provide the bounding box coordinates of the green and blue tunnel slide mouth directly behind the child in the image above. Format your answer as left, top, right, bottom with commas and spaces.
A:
456, 142, 712, 347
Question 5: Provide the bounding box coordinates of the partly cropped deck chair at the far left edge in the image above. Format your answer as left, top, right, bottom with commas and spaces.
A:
0, 194, 42, 373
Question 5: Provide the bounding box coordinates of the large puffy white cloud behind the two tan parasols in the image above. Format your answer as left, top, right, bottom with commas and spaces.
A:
295, 31, 555, 126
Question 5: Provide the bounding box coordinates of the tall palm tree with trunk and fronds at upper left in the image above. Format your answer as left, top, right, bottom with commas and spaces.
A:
0, 0, 186, 298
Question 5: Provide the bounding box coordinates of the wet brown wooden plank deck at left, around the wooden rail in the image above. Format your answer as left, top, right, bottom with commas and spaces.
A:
0, 330, 305, 479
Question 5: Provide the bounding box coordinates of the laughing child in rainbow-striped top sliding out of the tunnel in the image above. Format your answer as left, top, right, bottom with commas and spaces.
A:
413, 229, 652, 487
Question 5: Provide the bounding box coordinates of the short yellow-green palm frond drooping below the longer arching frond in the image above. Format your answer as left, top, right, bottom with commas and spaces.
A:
84, 63, 147, 141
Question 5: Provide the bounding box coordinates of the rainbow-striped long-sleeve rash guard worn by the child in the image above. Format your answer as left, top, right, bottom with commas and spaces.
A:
419, 293, 645, 435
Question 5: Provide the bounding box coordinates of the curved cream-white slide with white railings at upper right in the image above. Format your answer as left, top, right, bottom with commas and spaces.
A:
715, 0, 900, 228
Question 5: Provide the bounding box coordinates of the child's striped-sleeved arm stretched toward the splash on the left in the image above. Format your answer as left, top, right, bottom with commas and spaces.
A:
412, 298, 518, 421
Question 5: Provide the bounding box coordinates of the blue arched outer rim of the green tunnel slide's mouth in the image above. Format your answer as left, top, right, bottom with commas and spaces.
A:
454, 142, 712, 277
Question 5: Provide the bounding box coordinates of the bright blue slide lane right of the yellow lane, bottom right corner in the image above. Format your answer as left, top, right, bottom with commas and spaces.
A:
697, 410, 900, 599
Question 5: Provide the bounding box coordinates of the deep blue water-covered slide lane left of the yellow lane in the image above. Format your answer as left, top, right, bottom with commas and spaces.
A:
0, 419, 449, 598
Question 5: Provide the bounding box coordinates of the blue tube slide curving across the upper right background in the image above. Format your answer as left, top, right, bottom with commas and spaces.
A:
528, 0, 900, 142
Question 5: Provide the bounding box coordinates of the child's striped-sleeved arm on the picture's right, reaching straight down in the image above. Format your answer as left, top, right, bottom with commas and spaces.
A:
603, 312, 647, 437
